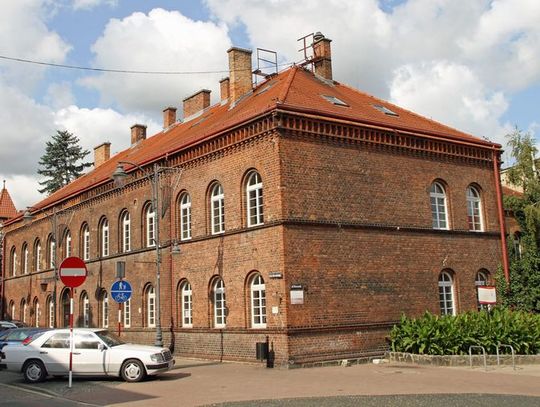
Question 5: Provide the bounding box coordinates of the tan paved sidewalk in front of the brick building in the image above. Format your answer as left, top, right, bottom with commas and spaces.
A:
54, 359, 540, 407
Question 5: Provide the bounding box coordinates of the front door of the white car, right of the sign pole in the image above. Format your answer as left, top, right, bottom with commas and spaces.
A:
73, 332, 108, 375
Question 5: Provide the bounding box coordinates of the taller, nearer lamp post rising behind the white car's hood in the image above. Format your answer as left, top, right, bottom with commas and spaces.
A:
111, 161, 179, 346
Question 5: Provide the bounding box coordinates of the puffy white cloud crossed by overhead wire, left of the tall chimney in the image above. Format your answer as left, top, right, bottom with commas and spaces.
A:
82, 9, 231, 113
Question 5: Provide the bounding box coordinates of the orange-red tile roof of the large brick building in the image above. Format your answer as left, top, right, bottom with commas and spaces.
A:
10, 66, 500, 223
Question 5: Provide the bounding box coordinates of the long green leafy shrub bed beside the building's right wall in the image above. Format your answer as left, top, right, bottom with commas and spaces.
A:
390, 308, 540, 355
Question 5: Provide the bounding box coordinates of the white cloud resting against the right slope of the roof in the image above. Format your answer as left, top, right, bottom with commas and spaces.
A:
390, 61, 510, 143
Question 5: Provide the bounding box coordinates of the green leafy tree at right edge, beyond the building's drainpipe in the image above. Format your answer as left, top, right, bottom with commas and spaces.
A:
500, 128, 540, 312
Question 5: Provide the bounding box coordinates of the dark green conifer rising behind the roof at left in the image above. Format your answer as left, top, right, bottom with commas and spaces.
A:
38, 130, 92, 194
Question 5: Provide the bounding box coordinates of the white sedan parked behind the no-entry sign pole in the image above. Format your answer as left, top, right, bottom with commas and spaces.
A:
2, 328, 174, 383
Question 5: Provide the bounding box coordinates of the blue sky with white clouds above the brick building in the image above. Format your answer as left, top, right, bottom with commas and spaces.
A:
0, 0, 540, 209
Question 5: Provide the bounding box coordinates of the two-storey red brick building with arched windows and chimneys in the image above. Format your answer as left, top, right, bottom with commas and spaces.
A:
3, 35, 504, 363
